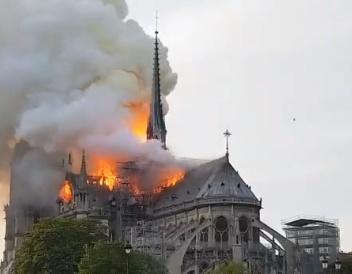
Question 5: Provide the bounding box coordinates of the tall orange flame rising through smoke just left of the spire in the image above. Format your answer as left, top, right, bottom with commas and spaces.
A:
124, 100, 150, 142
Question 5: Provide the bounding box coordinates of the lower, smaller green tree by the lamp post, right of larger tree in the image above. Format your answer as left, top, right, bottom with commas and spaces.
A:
79, 242, 167, 274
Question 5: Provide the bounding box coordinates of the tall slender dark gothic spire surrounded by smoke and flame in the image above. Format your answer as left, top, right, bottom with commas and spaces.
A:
147, 26, 167, 149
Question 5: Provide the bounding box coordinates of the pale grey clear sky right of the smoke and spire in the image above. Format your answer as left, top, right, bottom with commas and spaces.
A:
128, 0, 352, 251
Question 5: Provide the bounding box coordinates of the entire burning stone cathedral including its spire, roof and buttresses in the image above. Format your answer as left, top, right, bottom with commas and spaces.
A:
1, 29, 306, 274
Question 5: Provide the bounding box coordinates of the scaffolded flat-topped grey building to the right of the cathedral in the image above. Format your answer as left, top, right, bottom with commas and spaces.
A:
283, 217, 340, 274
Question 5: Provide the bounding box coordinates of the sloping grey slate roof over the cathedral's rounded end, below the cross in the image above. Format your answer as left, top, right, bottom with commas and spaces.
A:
155, 157, 258, 208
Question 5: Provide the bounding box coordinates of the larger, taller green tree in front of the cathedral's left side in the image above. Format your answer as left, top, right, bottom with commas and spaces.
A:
14, 219, 106, 274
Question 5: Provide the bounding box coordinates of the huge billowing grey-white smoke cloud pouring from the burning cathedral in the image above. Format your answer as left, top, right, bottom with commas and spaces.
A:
0, 0, 177, 211
